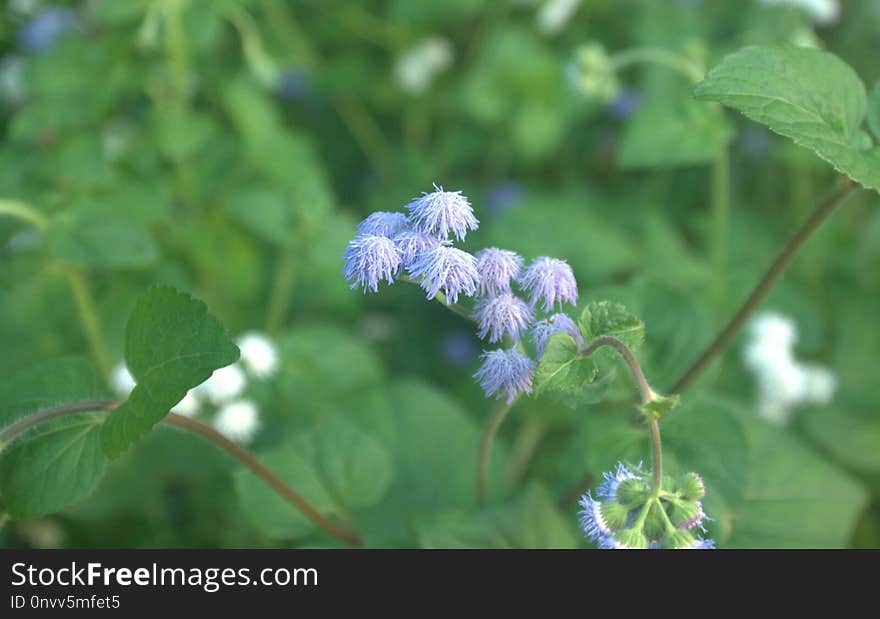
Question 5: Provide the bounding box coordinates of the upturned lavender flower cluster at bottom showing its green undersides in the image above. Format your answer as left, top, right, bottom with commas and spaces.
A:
580, 463, 715, 549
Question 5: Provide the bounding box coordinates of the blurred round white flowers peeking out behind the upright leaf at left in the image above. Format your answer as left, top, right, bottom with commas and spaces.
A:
110, 332, 279, 444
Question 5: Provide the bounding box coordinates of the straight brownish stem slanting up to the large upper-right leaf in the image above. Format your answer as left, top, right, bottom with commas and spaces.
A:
670, 181, 855, 393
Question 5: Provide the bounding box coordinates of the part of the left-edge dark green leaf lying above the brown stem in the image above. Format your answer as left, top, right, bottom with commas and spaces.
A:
0, 357, 107, 427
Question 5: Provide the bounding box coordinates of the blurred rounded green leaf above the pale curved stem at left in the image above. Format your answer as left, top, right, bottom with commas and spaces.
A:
46, 208, 159, 269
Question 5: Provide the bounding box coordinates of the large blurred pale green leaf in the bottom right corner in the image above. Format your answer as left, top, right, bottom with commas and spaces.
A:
728, 419, 868, 548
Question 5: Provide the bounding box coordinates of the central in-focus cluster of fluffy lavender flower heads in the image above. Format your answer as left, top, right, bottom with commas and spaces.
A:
343, 185, 582, 403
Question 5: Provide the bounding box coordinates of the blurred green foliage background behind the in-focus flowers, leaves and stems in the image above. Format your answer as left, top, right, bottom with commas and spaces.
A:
0, 0, 880, 547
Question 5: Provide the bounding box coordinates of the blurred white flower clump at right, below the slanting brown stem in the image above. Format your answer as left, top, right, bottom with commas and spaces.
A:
743, 312, 837, 425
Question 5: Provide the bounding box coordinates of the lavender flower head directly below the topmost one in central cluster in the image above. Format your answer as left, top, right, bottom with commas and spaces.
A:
408, 245, 480, 303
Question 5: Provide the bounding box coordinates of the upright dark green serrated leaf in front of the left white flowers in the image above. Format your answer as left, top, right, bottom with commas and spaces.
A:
101, 286, 239, 458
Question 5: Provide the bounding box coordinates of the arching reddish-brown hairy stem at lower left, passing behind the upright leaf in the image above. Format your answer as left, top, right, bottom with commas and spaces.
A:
0, 401, 363, 546
